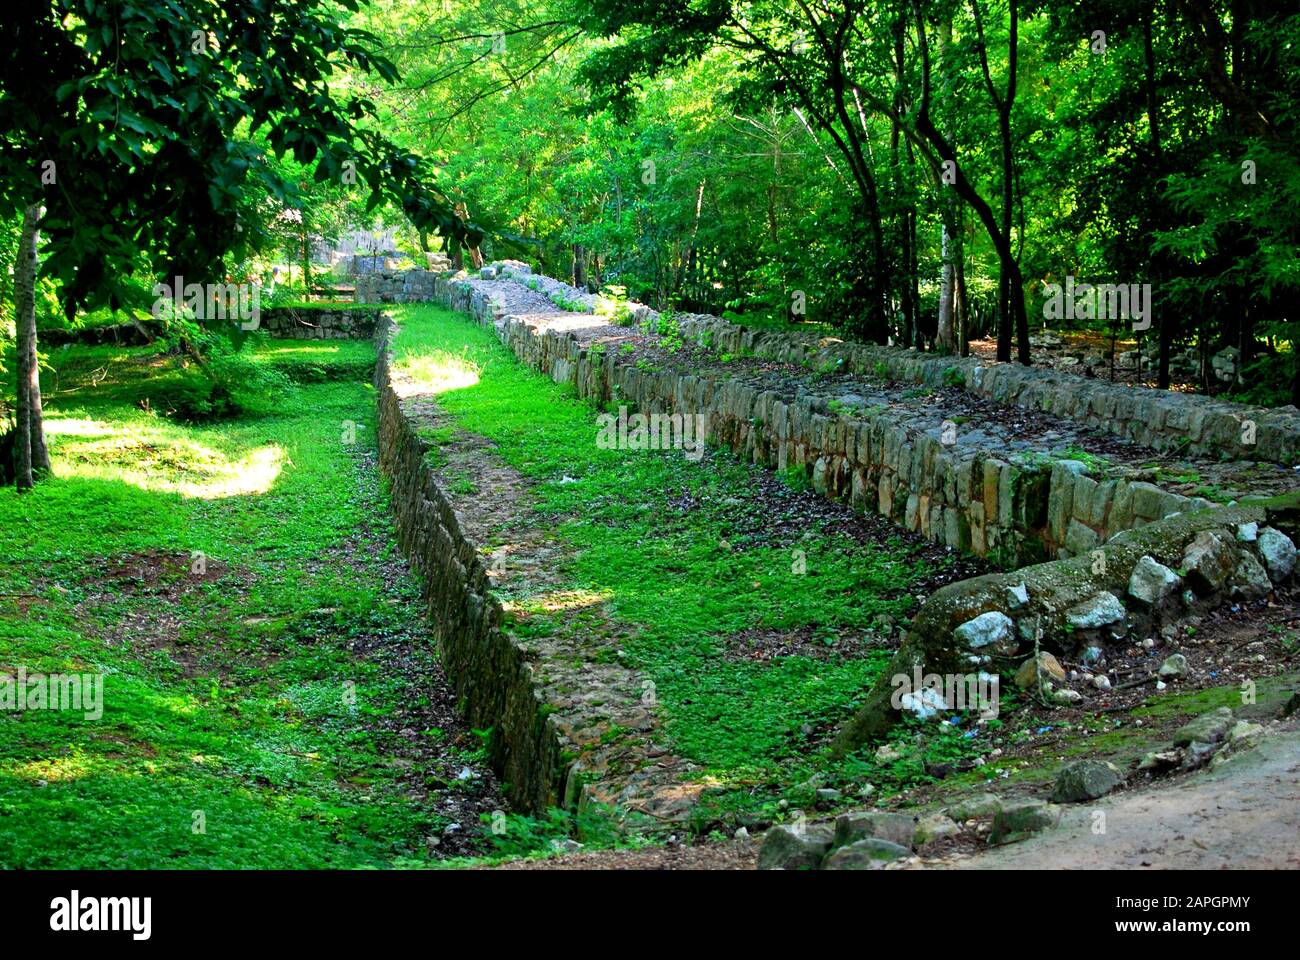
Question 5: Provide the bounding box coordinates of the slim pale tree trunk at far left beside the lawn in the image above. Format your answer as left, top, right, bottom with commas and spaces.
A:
13, 206, 49, 490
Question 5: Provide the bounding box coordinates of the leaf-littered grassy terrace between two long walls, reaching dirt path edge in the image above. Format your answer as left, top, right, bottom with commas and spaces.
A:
395, 306, 1300, 829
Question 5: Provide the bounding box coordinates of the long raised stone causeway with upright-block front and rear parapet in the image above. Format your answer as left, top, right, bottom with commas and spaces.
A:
436, 261, 1300, 566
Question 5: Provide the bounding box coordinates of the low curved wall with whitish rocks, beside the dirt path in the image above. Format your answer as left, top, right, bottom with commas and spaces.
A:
836, 494, 1300, 753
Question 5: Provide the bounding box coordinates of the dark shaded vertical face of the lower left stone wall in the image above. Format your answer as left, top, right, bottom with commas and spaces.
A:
374, 317, 566, 812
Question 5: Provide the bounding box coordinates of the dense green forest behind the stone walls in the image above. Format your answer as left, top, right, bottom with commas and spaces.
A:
0, 0, 1300, 416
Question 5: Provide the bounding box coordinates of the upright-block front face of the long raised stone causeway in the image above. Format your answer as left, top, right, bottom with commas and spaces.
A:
437, 268, 1212, 566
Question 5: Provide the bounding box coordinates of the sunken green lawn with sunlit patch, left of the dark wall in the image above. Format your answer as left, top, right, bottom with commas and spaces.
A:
0, 342, 499, 868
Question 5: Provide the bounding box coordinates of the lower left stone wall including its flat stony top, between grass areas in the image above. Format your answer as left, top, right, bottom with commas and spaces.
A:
374, 310, 706, 829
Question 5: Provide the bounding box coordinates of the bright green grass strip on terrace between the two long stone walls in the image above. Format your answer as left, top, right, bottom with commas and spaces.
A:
395, 306, 951, 801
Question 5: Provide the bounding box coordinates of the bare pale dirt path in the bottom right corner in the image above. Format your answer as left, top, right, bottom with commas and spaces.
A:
924, 719, 1300, 870
